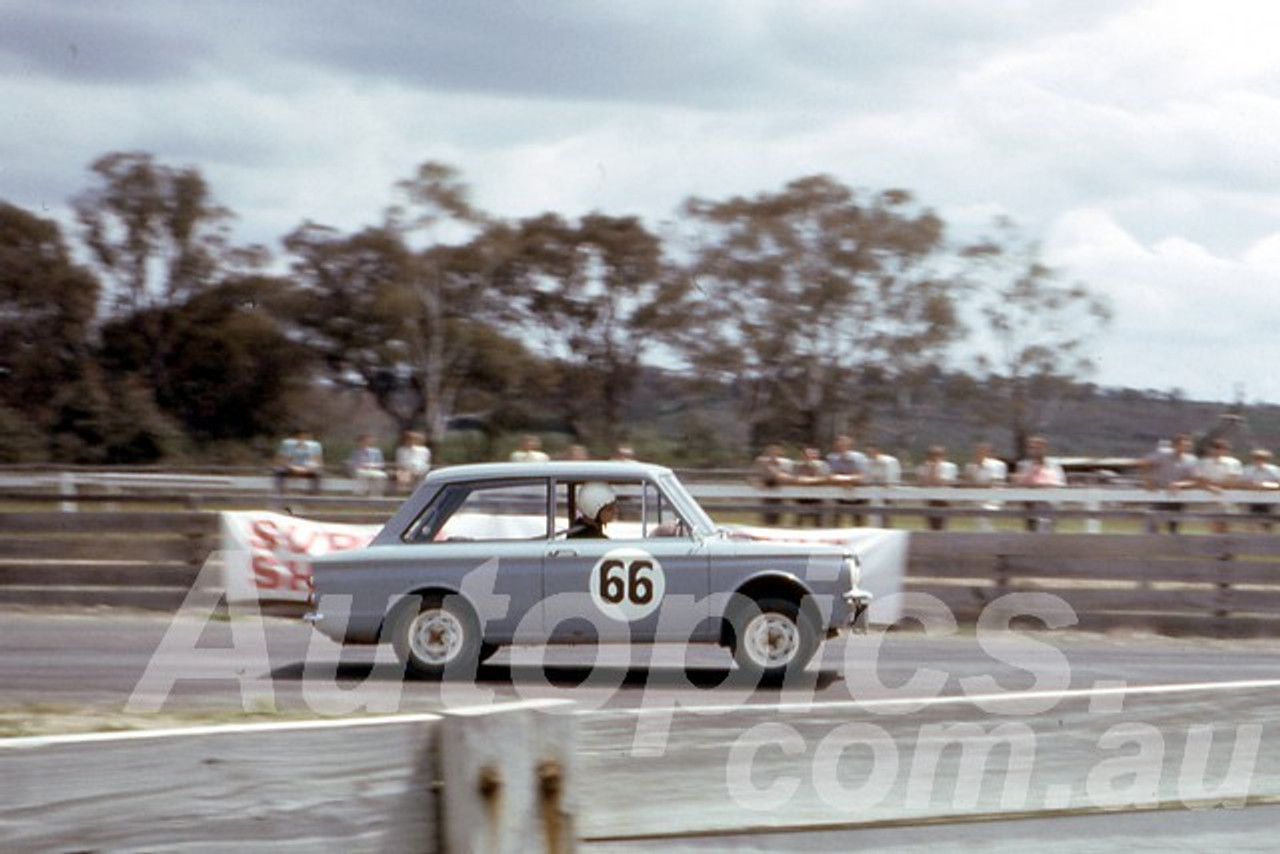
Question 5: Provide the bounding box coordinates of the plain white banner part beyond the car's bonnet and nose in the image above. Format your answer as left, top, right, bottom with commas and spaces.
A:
732, 525, 909, 625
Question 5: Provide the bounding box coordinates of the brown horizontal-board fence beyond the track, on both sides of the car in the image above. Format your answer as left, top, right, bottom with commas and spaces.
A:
0, 497, 1280, 636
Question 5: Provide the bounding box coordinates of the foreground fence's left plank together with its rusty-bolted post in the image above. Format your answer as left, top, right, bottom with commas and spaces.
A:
0, 703, 577, 854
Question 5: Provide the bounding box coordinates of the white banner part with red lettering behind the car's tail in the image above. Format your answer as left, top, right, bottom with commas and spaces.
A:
221, 511, 381, 602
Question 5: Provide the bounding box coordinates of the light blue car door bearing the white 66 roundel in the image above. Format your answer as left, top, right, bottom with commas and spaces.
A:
543, 479, 709, 643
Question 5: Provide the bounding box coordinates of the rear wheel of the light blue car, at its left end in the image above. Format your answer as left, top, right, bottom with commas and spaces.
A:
392, 595, 481, 679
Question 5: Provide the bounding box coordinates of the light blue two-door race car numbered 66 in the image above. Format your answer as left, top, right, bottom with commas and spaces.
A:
307, 461, 870, 681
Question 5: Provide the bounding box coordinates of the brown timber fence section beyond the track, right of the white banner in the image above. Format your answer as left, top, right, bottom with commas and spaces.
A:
908, 531, 1280, 636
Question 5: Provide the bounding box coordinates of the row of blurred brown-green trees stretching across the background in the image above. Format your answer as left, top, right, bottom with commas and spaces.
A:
0, 152, 1107, 462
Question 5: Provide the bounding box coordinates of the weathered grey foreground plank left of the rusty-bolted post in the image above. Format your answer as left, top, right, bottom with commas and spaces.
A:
0, 722, 436, 854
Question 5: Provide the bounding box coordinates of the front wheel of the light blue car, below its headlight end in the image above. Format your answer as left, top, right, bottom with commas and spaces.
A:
733, 598, 819, 682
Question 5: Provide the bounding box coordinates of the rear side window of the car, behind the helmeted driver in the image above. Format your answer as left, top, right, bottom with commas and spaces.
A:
404, 480, 548, 543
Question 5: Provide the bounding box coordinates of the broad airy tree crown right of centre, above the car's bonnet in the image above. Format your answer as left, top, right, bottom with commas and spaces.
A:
680, 175, 960, 442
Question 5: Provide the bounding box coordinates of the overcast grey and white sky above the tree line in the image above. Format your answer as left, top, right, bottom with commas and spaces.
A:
0, 0, 1280, 402
